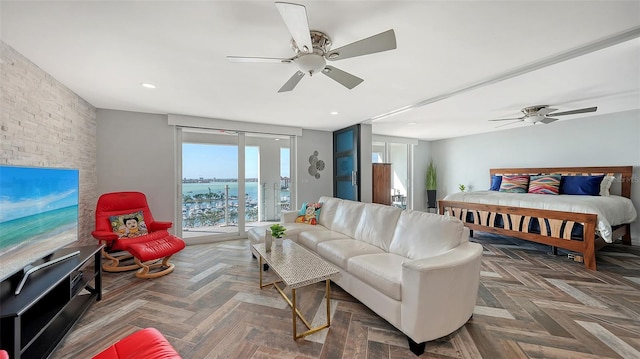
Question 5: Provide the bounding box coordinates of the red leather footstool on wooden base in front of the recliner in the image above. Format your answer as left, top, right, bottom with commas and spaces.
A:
127, 235, 185, 278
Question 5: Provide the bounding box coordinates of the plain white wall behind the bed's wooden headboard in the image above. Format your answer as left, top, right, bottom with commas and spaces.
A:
430, 110, 640, 245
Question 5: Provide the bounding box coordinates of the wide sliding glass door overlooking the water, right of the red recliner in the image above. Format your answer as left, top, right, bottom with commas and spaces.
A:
178, 129, 291, 243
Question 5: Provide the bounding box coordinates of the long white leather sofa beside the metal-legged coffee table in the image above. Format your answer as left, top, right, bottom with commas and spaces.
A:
248, 197, 482, 355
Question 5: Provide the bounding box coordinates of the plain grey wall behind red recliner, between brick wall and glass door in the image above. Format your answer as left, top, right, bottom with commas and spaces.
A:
97, 109, 176, 228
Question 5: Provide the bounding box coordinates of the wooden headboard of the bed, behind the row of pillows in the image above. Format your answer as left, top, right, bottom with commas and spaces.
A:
489, 166, 633, 198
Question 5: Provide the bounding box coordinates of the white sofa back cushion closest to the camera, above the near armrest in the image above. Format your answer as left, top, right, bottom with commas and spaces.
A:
389, 210, 464, 259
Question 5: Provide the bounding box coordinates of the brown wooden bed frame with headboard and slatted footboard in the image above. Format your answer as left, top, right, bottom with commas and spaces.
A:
438, 166, 633, 270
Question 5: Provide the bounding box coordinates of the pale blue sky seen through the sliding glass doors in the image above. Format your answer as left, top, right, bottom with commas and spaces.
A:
182, 143, 290, 178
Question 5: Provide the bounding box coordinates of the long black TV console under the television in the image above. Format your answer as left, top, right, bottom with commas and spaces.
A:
0, 245, 102, 359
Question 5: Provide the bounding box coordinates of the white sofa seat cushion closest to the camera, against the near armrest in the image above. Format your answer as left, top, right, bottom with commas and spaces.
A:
347, 253, 407, 300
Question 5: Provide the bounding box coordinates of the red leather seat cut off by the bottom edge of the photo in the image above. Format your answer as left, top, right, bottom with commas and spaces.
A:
93, 328, 181, 359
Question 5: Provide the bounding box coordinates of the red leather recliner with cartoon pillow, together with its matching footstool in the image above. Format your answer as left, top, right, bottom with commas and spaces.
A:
91, 192, 185, 278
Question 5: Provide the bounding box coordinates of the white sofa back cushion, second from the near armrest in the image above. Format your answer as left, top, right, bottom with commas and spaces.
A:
355, 204, 402, 252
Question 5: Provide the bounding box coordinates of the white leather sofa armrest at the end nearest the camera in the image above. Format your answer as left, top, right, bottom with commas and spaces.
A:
401, 242, 483, 343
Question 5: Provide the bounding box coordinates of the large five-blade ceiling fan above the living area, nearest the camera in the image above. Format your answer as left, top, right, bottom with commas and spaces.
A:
227, 2, 396, 92
